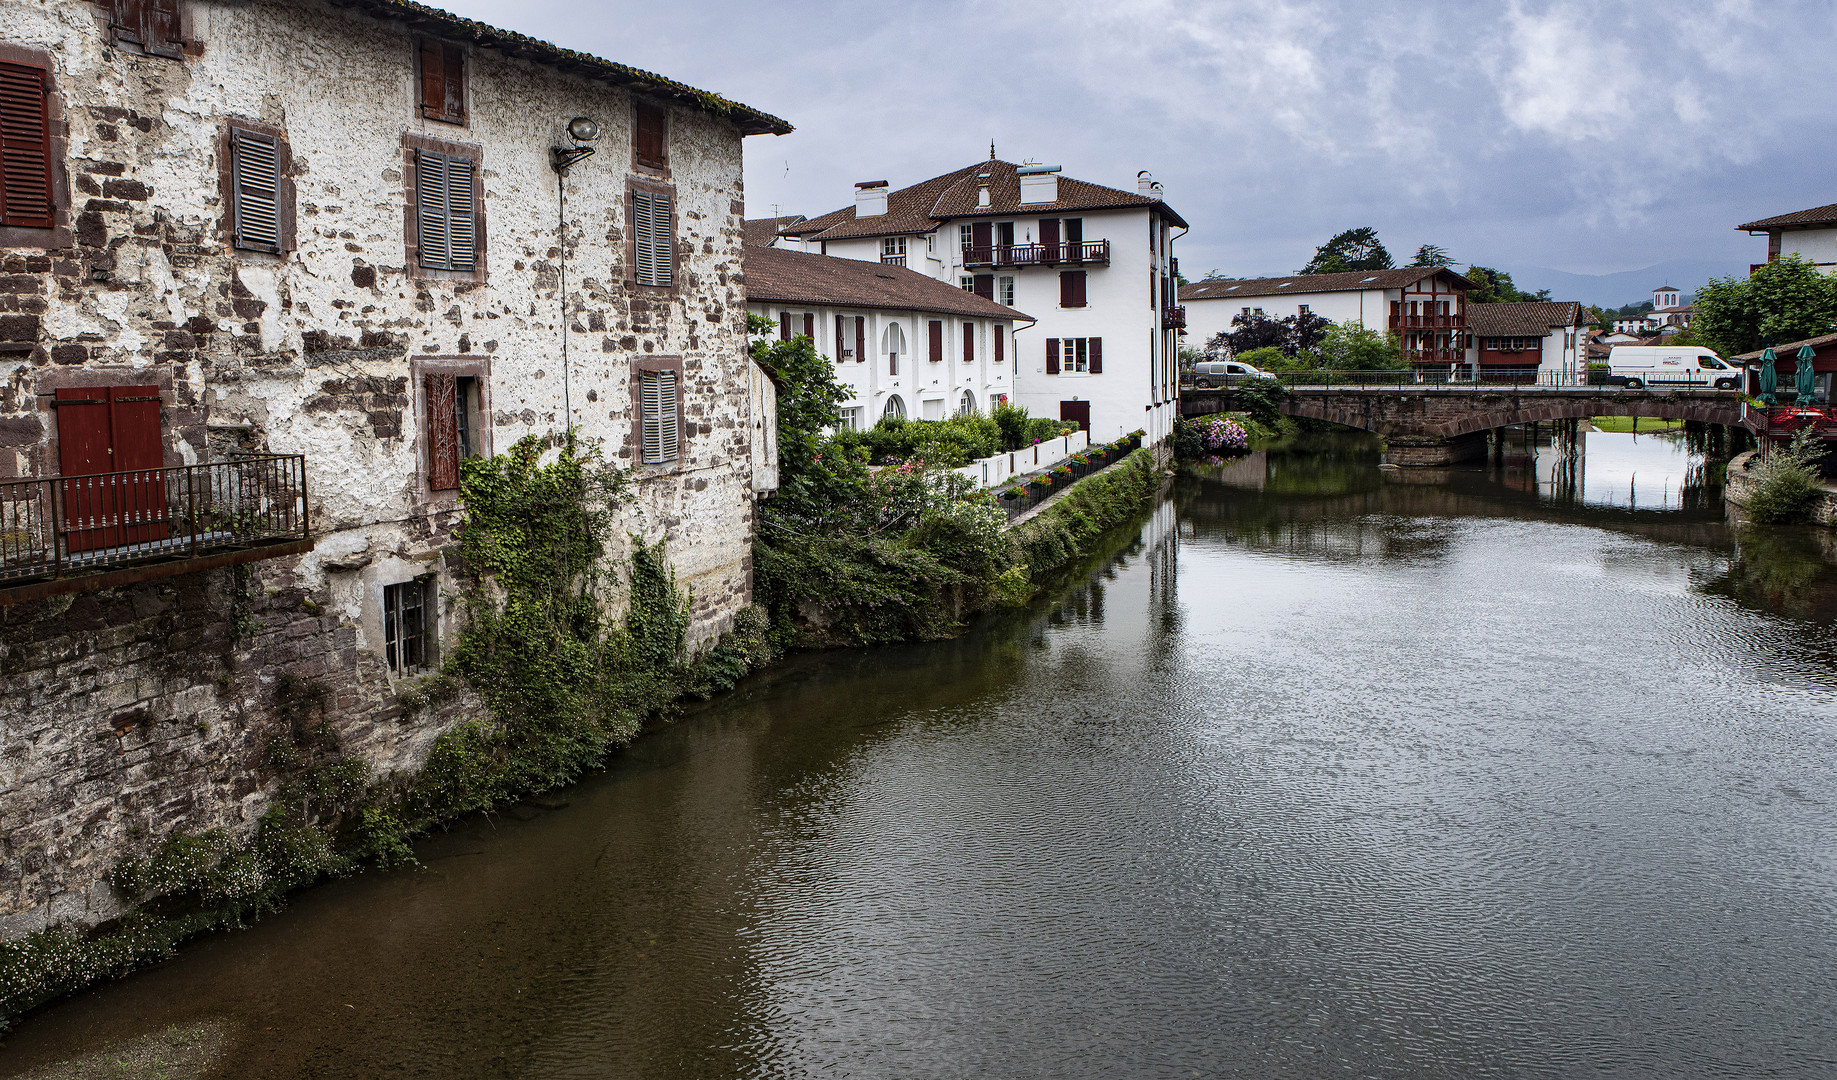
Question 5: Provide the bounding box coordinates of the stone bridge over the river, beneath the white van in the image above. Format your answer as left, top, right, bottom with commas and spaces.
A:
1179, 384, 1741, 465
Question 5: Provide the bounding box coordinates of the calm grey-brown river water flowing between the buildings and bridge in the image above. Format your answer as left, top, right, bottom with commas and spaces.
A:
0, 435, 1837, 1078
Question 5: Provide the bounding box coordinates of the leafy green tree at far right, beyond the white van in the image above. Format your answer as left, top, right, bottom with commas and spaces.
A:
1690, 255, 1837, 356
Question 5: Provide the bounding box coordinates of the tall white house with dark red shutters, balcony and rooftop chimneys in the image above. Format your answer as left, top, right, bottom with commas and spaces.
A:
777, 158, 1187, 444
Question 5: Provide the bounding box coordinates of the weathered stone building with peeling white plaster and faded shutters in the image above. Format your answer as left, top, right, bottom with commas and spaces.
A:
0, 0, 790, 937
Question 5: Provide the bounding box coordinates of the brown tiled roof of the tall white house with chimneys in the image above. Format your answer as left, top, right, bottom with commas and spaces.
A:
790, 160, 1187, 241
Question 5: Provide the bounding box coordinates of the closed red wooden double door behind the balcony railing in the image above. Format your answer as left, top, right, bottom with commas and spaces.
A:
57, 386, 169, 551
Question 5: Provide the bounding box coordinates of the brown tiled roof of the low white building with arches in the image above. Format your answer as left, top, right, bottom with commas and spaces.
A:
744, 246, 1034, 321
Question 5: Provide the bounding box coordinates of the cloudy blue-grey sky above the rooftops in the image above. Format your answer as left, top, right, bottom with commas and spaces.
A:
435, 0, 1837, 288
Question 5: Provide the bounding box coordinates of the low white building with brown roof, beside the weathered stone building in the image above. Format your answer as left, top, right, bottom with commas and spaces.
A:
746, 246, 1032, 430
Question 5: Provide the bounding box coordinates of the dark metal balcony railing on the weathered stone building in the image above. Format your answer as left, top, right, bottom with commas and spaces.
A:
0, 454, 312, 604
